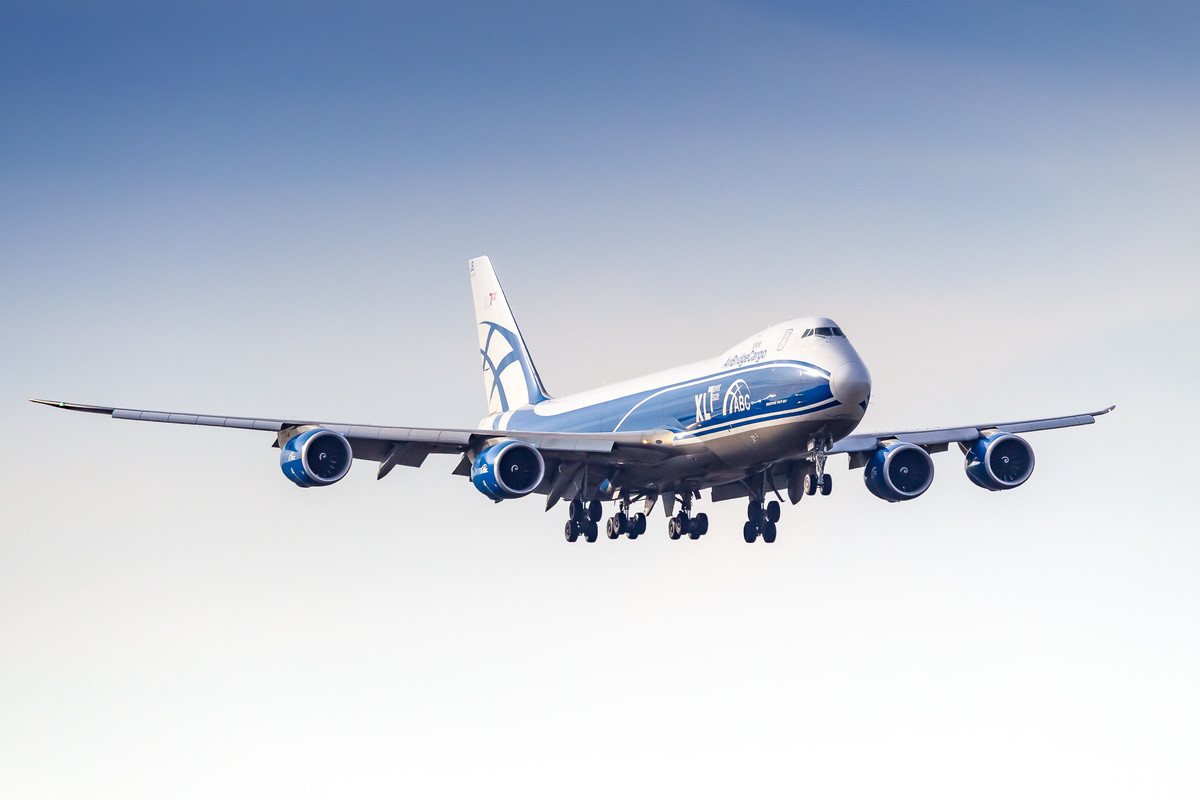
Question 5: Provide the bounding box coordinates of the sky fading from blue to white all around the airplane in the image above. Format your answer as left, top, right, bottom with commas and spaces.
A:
0, 0, 1200, 798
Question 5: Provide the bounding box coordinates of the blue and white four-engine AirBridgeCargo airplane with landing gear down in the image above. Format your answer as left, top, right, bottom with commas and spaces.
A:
31, 255, 1115, 543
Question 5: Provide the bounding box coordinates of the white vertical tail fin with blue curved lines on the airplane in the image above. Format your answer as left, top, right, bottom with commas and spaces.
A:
468, 255, 548, 415
